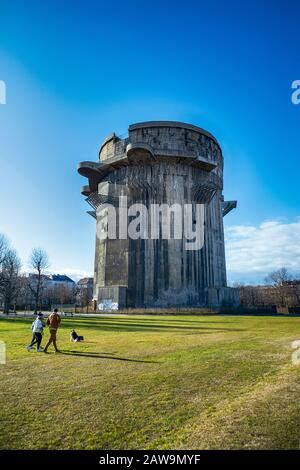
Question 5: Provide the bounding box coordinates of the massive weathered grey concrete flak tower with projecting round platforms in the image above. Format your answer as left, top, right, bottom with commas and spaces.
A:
78, 121, 239, 309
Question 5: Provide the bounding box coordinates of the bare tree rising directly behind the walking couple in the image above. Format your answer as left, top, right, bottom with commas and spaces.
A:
29, 248, 49, 313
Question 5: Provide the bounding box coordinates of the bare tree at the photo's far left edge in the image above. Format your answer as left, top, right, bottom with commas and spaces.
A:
2, 249, 21, 313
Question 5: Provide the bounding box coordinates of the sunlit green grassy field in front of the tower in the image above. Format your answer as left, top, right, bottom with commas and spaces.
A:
0, 316, 300, 449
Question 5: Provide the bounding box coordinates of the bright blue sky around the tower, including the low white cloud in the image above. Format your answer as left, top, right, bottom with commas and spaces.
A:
0, 0, 300, 282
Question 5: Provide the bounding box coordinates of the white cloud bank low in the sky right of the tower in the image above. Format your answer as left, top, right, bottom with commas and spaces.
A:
225, 218, 300, 282
